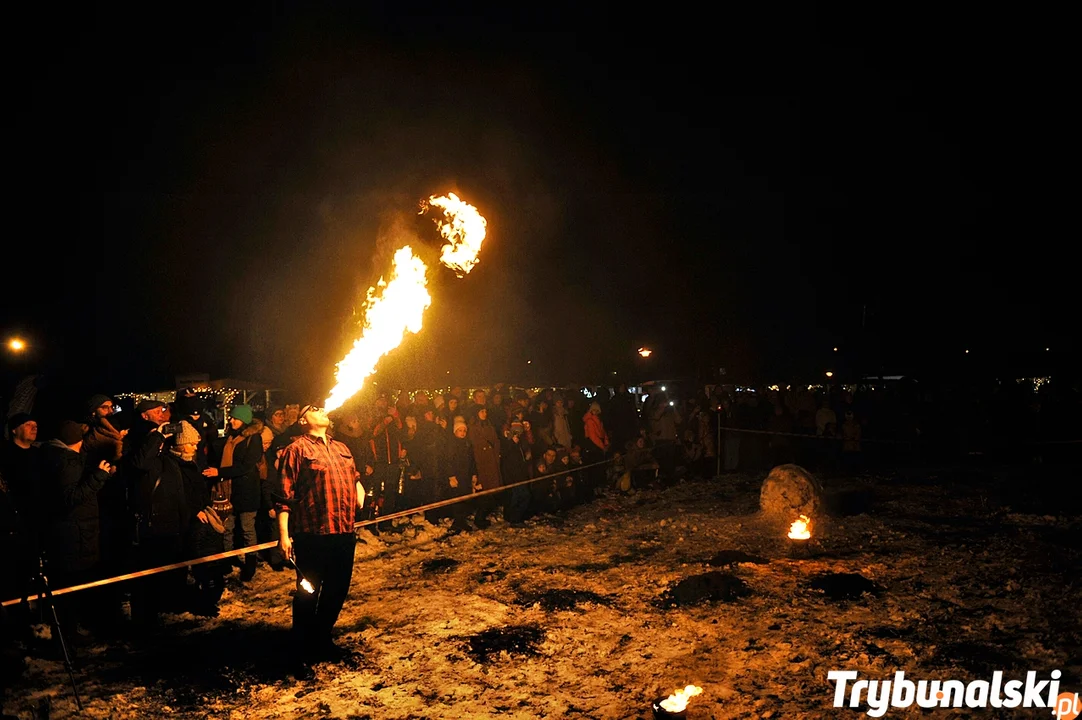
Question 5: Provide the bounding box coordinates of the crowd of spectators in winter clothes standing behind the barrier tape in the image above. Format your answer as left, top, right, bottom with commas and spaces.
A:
0, 376, 1082, 666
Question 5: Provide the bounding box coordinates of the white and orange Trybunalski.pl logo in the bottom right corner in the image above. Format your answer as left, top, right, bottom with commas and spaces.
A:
827, 670, 1082, 720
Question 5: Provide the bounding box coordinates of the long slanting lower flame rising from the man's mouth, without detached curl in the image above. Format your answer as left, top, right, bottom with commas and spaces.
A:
324, 245, 432, 411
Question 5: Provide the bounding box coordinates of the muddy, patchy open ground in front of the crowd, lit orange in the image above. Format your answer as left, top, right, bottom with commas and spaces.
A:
3, 466, 1082, 720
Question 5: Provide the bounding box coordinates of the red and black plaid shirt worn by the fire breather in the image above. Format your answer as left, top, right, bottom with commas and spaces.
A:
281, 435, 360, 535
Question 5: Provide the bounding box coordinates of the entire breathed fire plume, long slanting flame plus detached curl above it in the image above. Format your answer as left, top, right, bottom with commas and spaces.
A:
324, 193, 487, 411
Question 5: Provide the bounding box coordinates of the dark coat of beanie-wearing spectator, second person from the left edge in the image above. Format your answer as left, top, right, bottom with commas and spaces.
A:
41, 440, 109, 573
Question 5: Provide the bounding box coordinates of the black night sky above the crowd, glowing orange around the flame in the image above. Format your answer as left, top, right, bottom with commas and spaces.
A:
0, 3, 1078, 394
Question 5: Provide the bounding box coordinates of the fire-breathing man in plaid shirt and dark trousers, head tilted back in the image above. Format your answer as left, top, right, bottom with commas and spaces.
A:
277, 405, 365, 679
